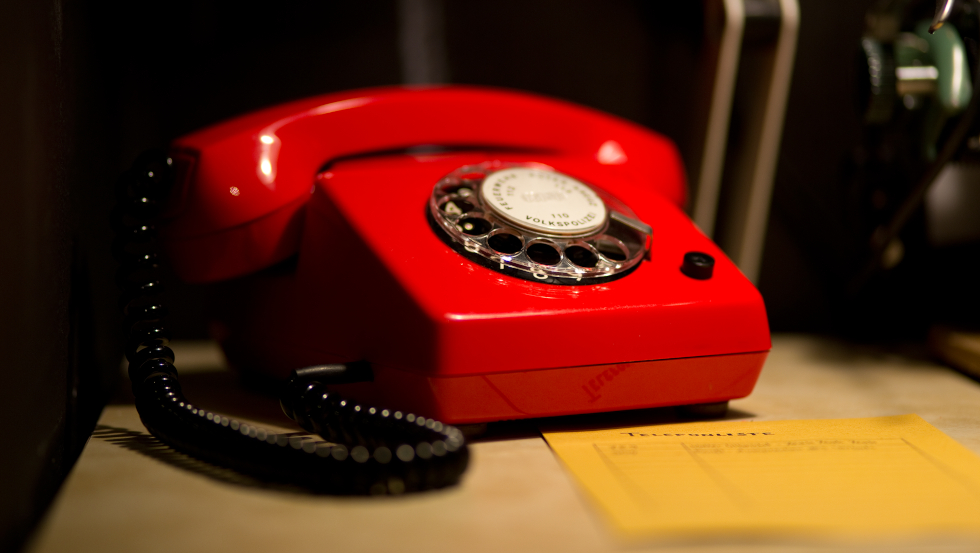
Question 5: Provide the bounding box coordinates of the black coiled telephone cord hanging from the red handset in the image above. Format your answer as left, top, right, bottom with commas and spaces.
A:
112, 153, 469, 495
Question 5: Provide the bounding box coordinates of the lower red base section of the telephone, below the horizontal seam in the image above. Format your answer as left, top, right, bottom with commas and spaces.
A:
322, 351, 768, 424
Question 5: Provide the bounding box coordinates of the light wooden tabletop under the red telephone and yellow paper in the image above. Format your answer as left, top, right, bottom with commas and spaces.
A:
26, 335, 980, 553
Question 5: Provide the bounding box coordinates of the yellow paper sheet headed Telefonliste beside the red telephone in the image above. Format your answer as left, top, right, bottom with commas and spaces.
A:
544, 415, 980, 538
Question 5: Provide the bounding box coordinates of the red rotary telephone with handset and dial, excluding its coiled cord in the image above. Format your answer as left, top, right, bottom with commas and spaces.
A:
161, 86, 770, 424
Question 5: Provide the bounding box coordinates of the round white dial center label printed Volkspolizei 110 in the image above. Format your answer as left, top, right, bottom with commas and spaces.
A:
480, 167, 607, 236
